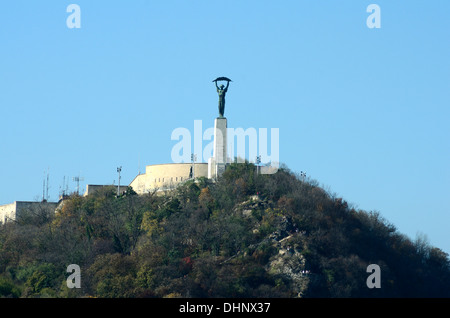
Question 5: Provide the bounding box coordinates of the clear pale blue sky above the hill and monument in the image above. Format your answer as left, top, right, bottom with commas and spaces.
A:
0, 0, 450, 253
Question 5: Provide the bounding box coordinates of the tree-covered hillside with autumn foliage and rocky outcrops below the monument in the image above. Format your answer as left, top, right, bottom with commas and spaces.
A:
0, 164, 450, 297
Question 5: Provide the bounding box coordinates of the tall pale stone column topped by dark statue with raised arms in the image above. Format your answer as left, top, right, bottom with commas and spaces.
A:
208, 77, 231, 179
